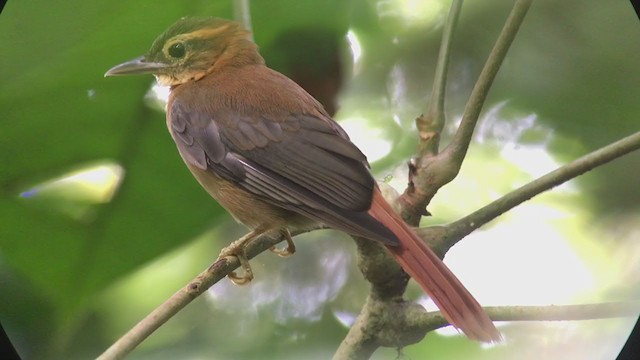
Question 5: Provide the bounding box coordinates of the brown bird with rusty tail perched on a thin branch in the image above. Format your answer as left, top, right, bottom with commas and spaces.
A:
105, 17, 501, 342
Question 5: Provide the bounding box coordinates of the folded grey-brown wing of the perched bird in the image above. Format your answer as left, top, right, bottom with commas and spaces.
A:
169, 100, 395, 244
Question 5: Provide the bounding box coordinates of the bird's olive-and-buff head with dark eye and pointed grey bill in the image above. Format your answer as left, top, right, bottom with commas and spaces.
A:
105, 17, 264, 86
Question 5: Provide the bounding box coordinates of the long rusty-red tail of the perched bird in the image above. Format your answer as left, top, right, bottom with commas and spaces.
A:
369, 189, 501, 342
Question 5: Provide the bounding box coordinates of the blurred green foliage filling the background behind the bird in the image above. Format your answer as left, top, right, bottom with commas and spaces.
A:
0, 0, 640, 359
